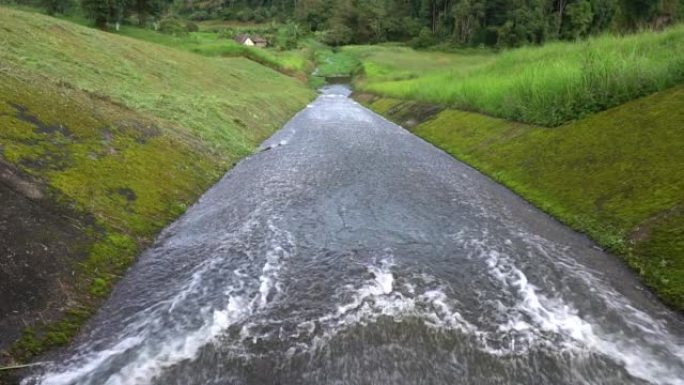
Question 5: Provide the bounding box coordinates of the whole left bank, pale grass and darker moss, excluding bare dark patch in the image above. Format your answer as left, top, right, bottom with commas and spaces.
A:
0, 7, 313, 361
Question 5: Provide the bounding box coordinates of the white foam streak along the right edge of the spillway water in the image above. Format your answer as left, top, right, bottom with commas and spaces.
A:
480, 234, 684, 385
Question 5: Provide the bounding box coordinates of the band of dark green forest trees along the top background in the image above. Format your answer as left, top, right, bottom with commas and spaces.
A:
5, 0, 684, 48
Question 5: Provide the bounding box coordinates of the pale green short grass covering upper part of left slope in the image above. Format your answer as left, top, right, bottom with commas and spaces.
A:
0, 8, 312, 155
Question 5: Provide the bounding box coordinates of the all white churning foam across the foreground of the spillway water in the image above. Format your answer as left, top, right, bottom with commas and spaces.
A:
28, 222, 684, 385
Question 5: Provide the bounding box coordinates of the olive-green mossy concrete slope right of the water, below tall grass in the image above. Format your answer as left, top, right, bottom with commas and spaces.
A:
357, 86, 684, 310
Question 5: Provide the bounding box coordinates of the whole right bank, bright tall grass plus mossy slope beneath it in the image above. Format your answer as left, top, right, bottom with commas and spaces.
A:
352, 32, 684, 310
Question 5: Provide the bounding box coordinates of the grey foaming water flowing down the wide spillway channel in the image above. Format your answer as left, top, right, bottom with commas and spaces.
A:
25, 86, 684, 385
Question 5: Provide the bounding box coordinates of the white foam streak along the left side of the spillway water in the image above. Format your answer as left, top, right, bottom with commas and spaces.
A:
32, 222, 294, 385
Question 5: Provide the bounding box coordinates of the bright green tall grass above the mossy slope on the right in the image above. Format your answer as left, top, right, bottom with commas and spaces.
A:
362, 25, 684, 126
